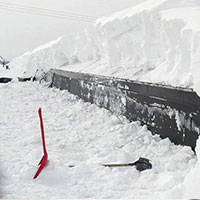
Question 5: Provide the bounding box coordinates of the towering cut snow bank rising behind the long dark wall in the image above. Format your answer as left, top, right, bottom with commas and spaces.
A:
8, 0, 200, 94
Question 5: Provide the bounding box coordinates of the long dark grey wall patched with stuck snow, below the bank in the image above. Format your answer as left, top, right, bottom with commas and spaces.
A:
47, 70, 200, 150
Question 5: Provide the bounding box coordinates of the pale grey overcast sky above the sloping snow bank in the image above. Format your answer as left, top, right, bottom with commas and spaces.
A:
0, 0, 146, 59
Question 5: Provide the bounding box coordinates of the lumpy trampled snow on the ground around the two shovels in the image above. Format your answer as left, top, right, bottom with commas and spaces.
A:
0, 81, 200, 199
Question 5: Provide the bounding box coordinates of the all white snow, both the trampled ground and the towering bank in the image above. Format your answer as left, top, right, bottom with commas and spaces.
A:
0, 0, 200, 199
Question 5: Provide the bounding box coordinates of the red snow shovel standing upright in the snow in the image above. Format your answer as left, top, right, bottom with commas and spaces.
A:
33, 108, 48, 179
